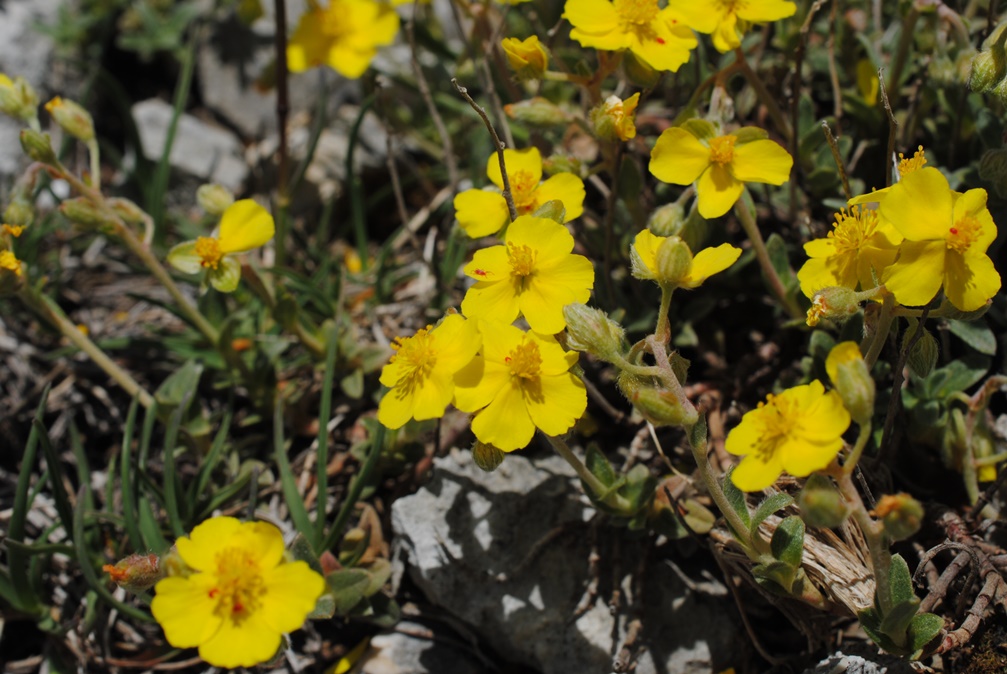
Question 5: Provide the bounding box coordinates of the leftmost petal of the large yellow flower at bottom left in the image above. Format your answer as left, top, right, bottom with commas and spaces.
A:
150, 572, 222, 648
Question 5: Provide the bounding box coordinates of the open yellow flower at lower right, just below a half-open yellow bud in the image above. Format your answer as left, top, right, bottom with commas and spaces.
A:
724, 380, 850, 492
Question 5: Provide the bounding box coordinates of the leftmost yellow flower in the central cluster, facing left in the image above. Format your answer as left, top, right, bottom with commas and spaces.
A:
378, 313, 480, 428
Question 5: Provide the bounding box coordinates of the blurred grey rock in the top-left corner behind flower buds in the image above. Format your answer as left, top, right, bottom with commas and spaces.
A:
0, 0, 62, 177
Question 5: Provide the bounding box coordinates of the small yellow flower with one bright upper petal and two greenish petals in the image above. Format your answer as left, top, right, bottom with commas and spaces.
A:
168, 198, 275, 292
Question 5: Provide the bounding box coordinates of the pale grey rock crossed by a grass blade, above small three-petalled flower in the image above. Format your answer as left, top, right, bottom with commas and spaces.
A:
133, 99, 249, 191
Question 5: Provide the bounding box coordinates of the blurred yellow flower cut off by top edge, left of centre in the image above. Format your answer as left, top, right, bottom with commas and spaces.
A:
287, 0, 399, 80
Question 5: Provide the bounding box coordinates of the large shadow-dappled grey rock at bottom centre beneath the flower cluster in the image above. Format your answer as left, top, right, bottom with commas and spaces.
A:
392, 452, 739, 674
